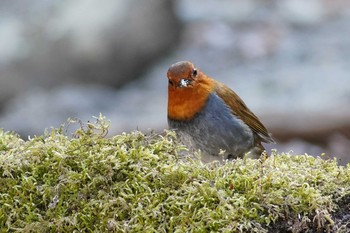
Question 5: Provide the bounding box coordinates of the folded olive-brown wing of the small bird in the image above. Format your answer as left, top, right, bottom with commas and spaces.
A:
215, 82, 275, 143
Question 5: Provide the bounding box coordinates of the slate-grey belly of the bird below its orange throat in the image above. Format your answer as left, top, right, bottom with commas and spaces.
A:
168, 94, 254, 158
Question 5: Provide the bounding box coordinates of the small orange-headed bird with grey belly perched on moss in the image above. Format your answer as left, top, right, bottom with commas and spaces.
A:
167, 61, 274, 162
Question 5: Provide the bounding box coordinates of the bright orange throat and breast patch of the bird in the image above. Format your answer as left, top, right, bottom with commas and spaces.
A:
168, 77, 215, 121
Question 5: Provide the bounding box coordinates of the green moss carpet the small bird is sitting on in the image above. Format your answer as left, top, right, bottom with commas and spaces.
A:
0, 116, 350, 232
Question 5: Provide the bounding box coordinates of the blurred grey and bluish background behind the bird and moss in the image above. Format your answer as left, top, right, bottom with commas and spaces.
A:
0, 0, 350, 164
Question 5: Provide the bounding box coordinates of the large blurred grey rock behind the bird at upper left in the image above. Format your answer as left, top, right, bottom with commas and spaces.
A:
0, 0, 180, 105
